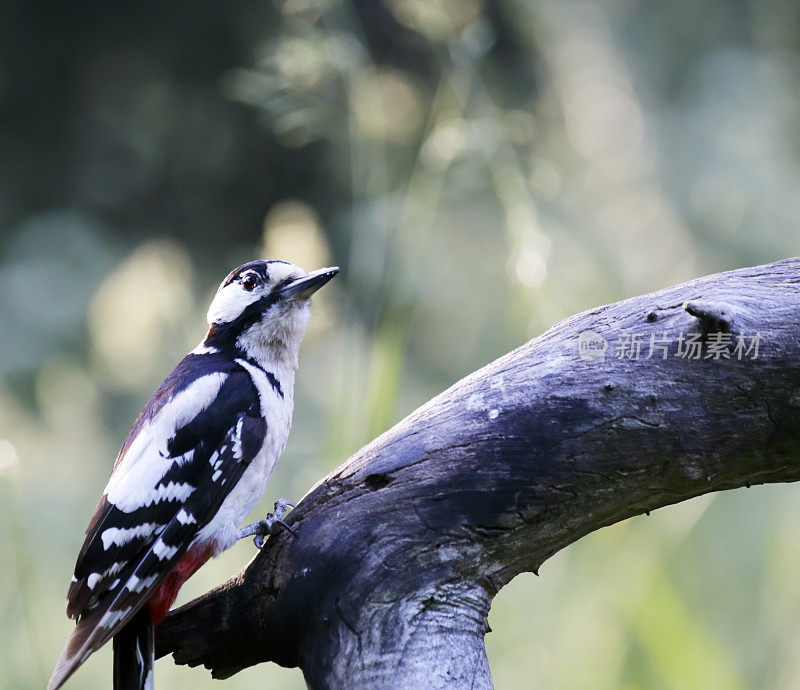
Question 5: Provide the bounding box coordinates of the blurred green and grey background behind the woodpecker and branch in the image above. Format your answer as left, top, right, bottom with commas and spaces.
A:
0, 0, 800, 690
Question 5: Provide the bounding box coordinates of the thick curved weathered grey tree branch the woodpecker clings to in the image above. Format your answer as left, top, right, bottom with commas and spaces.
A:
157, 259, 800, 689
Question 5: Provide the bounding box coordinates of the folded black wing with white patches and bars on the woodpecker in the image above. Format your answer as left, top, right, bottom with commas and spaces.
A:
48, 355, 266, 689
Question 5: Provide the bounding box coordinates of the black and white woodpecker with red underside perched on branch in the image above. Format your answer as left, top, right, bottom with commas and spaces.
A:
47, 260, 339, 690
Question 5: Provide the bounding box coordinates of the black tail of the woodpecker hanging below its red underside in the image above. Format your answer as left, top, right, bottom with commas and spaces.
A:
114, 606, 155, 690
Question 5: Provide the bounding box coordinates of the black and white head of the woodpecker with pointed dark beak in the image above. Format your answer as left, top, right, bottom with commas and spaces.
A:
204, 261, 339, 366
